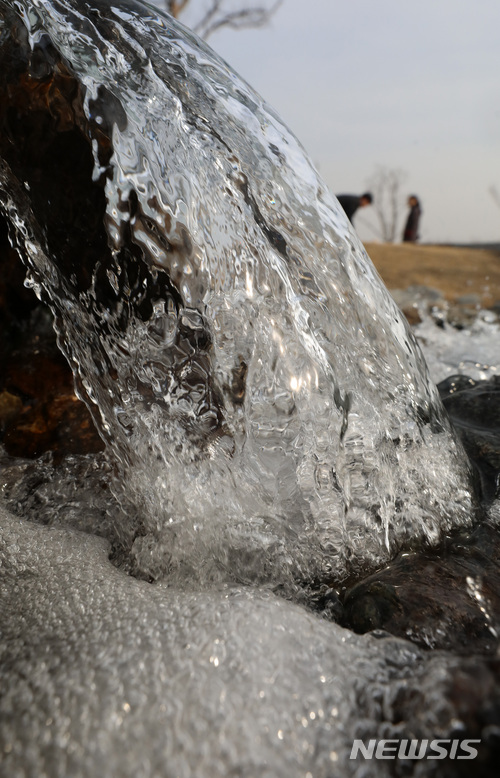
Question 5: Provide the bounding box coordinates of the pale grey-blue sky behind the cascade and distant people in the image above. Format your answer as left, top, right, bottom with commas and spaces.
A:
170, 0, 500, 243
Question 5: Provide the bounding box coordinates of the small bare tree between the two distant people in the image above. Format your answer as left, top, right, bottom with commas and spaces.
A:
367, 165, 407, 243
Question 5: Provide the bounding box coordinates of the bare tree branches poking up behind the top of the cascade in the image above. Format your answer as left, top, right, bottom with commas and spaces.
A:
164, 0, 283, 39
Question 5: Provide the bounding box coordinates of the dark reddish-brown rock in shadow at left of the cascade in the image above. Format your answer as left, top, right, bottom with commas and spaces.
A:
0, 214, 103, 458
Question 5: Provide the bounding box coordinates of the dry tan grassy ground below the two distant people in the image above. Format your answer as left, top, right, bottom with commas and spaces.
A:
365, 243, 500, 308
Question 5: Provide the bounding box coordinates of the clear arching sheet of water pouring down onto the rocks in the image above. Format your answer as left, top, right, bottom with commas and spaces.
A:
0, 0, 472, 583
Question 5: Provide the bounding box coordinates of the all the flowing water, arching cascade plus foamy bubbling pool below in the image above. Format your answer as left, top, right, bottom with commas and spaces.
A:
0, 0, 495, 778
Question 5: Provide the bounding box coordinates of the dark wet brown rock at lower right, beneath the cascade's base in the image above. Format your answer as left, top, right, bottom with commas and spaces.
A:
343, 526, 500, 655
